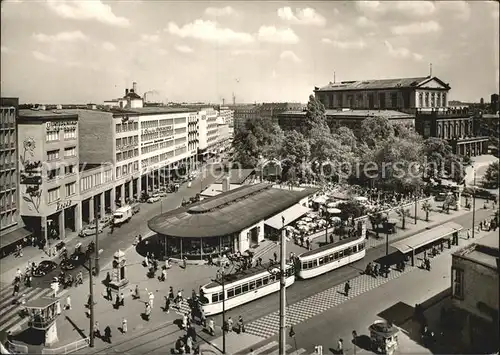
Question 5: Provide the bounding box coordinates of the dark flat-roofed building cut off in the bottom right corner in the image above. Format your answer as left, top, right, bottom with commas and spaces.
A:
450, 235, 500, 354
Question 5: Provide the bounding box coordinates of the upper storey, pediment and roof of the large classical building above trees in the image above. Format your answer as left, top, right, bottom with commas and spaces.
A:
314, 76, 450, 111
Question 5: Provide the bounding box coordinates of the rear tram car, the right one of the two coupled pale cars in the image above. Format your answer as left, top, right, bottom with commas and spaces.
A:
295, 235, 366, 279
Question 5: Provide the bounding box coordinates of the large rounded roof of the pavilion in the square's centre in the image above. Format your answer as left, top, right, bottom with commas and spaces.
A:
148, 183, 317, 238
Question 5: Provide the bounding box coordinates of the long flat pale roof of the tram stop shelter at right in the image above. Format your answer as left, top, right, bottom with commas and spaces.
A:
391, 222, 463, 254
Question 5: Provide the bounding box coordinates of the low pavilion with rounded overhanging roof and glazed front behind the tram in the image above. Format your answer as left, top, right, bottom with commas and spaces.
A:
148, 183, 317, 259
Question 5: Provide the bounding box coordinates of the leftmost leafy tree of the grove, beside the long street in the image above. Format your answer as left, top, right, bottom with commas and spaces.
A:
233, 118, 284, 168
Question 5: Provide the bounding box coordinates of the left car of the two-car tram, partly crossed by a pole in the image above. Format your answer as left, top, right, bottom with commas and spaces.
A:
200, 264, 295, 316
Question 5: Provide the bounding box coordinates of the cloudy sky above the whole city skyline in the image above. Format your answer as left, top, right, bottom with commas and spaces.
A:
1, 0, 499, 103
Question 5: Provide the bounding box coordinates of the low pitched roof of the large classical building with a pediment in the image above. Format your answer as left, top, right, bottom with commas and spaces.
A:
314, 76, 447, 91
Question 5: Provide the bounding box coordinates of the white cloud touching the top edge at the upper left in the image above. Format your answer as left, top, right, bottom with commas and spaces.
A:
47, 0, 130, 27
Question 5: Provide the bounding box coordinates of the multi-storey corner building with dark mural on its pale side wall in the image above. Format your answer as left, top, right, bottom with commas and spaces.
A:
17, 110, 81, 246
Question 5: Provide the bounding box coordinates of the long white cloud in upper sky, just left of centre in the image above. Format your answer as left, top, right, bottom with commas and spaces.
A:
166, 20, 255, 44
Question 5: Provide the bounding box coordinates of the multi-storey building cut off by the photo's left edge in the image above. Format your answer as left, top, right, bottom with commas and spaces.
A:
0, 97, 29, 252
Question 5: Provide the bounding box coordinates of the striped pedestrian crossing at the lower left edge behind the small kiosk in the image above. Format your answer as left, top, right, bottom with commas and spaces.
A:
0, 285, 53, 332
